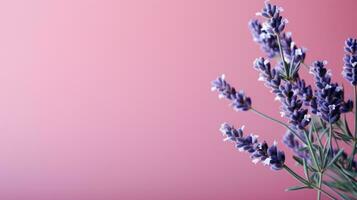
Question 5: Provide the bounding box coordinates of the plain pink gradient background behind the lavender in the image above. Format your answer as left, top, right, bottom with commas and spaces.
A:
0, 0, 357, 200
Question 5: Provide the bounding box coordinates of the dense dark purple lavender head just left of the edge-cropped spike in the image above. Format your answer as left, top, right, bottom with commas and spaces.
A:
310, 61, 353, 123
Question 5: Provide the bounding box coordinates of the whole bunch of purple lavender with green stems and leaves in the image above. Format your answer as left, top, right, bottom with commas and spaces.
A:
212, 2, 357, 200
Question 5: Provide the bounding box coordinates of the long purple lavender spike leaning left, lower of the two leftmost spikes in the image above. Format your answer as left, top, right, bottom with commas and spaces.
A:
220, 123, 285, 170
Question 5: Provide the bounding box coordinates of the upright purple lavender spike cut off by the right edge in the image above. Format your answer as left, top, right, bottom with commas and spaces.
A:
342, 38, 357, 86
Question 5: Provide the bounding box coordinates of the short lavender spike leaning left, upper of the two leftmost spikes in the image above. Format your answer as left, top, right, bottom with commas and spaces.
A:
211, 75, 252, 111
